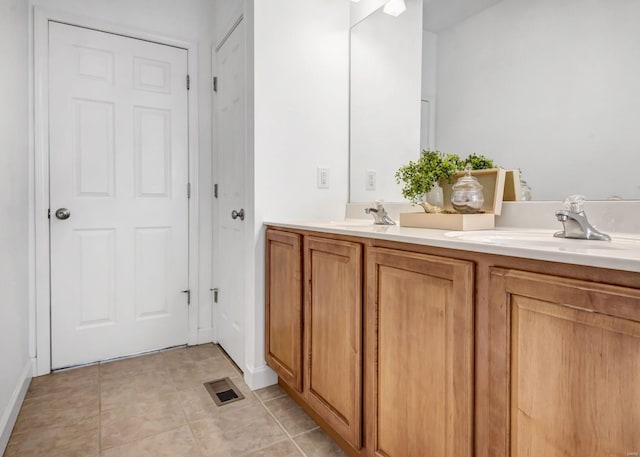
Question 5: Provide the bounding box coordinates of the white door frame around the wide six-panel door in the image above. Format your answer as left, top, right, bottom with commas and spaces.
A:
29, 7, 199, 376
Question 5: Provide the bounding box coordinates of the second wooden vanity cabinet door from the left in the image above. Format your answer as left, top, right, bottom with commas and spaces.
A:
304, 237, 362, 449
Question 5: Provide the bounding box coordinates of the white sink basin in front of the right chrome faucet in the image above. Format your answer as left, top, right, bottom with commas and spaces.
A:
445, 230, 640, 252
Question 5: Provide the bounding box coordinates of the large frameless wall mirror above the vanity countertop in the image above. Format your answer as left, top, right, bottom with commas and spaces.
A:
350, 0, 640, 202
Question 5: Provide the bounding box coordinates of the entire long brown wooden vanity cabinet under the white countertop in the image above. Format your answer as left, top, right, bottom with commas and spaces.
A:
266, 225, 640, 457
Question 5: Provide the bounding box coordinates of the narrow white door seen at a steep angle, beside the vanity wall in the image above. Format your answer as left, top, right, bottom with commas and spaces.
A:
214, 21, 247, 369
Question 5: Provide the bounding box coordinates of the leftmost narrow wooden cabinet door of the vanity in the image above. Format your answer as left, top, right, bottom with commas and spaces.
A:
265, 230, 302, 392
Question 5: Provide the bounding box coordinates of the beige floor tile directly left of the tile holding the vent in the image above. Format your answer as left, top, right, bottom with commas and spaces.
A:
100, 393, 186, 449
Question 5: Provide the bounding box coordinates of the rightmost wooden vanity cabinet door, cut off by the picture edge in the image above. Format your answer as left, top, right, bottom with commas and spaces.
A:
483, 268, 640, 457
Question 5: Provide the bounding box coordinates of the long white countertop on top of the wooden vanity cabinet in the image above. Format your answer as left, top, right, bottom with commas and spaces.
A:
265, 219, 640, 272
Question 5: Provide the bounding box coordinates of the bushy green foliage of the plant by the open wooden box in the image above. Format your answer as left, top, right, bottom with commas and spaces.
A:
395, 150, 495, 204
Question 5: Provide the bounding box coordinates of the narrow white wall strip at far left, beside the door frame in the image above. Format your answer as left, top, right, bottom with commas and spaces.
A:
0, 0, 31, 448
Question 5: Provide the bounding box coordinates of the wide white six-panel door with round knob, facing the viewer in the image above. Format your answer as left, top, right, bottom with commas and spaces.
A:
49, 22, 189, 369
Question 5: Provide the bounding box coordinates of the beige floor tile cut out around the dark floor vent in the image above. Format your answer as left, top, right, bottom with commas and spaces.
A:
178, 377, 259, 422
